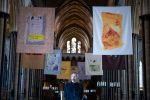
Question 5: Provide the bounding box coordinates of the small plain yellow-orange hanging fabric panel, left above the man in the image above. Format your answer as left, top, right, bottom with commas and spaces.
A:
57, 61, 72, 79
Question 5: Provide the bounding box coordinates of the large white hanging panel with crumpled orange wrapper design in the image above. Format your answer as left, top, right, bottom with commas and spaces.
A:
93, 6, 133, 55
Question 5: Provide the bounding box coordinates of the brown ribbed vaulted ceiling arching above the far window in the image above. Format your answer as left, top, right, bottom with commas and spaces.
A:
32, 0, 107, 52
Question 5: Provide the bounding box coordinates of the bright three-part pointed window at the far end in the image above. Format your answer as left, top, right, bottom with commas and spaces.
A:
67, 37, 81, 53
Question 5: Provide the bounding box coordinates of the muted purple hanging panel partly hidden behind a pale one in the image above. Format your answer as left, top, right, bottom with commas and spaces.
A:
77, 62, 91, 80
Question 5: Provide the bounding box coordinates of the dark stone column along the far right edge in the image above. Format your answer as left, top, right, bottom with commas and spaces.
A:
140, 14, 150, 100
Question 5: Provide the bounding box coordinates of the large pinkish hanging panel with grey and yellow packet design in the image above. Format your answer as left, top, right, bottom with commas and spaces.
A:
17, 7, 55, 53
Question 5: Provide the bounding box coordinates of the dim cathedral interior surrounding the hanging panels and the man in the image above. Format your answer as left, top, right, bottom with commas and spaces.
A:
0, 0, 150, 100
